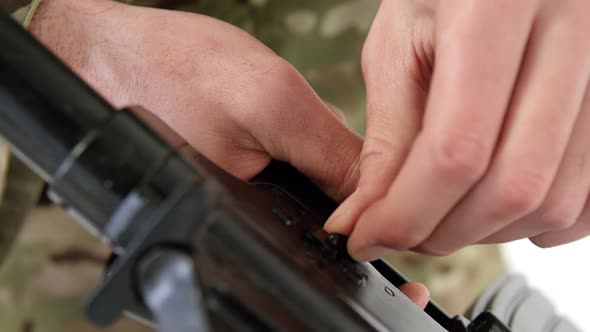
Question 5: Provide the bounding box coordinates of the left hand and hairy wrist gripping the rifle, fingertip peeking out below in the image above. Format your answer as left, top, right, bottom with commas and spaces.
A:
30, 0, 429, 307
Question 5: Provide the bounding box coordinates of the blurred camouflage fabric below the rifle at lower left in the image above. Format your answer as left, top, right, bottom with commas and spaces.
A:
0, 206, 150, 332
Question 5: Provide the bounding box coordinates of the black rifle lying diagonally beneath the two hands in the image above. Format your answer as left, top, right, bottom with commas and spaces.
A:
0, 15, 509, 332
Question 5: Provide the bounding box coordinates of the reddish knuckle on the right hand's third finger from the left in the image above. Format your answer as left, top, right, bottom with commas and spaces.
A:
493, 168, 551, 215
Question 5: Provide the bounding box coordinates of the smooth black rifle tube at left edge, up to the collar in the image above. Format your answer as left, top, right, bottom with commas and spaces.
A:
0, 13, 113, 182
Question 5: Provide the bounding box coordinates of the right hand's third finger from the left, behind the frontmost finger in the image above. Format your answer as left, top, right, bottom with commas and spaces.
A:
423, 6, 590, 253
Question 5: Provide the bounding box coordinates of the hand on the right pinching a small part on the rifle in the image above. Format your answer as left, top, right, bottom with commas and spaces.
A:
326, 0, 590, 260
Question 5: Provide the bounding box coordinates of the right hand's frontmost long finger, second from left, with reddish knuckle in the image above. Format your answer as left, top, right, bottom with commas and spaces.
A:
349, 1, 532, 260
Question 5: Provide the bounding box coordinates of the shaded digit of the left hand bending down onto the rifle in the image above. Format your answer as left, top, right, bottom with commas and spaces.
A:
247, 63, 362, 201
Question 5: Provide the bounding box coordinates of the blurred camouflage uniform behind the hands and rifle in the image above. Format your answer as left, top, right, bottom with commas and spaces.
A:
0, 0, 503, 332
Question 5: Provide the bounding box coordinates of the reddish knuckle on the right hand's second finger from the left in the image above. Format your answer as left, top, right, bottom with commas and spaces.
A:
431, 134, 490, 181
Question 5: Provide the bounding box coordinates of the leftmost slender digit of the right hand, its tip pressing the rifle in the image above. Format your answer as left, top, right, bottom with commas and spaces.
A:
325, 1, 427, 234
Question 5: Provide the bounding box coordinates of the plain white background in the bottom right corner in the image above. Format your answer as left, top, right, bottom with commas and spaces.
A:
503, 238, 590, 331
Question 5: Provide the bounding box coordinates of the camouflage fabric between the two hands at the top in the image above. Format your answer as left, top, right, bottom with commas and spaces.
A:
122, 0, 380, 133
